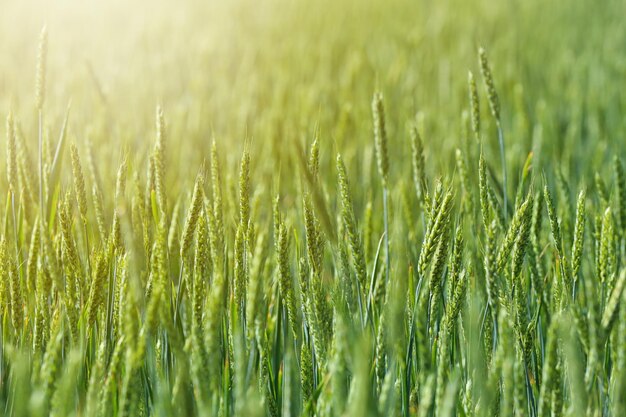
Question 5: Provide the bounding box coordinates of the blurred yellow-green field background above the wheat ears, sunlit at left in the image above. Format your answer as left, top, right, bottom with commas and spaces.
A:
0, 0, 626, 192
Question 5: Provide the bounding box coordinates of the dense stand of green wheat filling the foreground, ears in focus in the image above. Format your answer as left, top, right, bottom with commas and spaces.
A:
0, 30, 626, 417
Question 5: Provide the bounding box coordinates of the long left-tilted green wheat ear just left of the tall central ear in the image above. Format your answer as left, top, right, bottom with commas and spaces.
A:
337, 155, 367, 295
